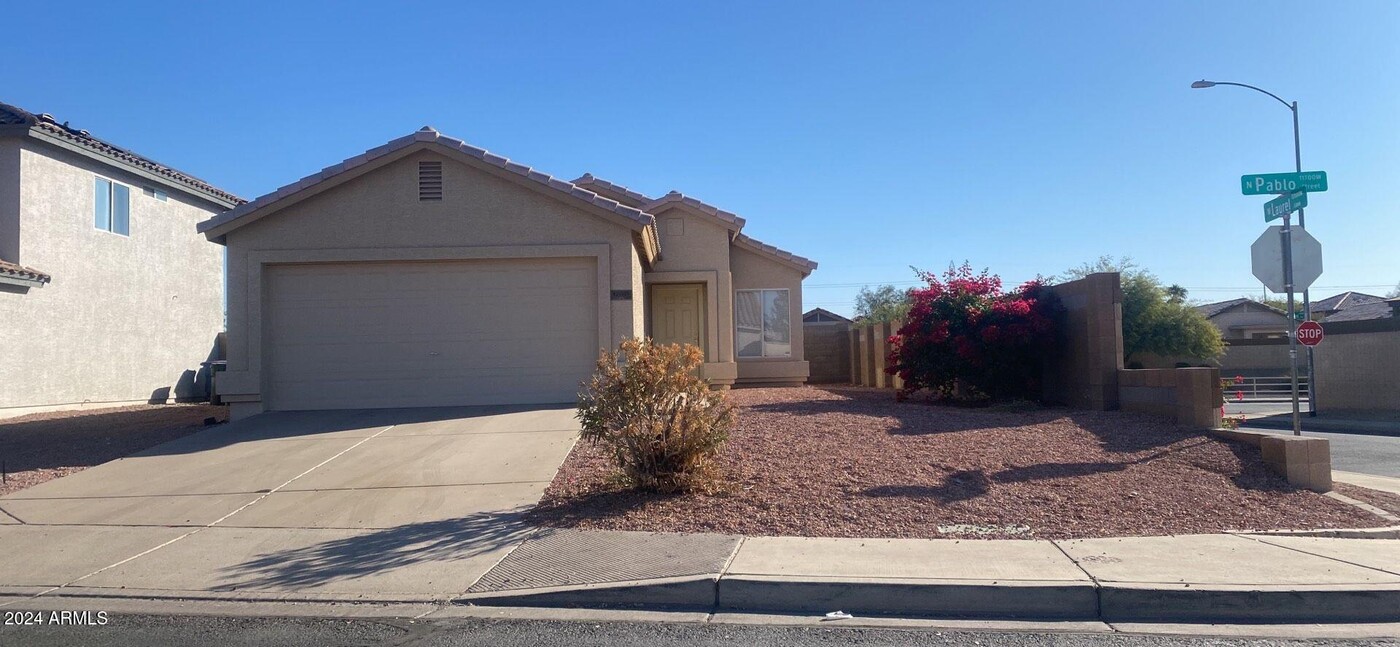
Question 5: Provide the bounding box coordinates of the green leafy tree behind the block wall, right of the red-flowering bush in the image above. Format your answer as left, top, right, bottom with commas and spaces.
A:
1060, 256, 1225, 360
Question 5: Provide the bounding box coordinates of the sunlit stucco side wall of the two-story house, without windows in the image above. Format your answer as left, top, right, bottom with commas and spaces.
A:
0, 139, 223, 416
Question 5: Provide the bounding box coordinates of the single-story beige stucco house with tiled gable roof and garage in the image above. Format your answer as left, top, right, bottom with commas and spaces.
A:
199, 127, 816, 417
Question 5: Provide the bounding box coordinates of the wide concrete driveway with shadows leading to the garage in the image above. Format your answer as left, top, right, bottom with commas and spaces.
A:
0, 406, 578, 605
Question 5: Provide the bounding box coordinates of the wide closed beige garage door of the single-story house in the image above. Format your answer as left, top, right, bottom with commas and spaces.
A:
263, 259, 598, 410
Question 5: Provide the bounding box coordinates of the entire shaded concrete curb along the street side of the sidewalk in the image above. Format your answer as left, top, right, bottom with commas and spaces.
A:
452, 576, 1400, 623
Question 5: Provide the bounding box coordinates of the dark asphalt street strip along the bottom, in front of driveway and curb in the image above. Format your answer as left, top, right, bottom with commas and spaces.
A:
0, 616, 1400, 647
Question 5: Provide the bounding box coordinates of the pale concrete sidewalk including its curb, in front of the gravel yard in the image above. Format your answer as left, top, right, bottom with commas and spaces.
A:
458, 531, 1400, 622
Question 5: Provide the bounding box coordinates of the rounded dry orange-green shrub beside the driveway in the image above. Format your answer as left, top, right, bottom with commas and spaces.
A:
578, 339, 735, 493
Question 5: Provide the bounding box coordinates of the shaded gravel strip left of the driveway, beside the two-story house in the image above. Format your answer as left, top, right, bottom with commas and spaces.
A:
0, 405, 228, 494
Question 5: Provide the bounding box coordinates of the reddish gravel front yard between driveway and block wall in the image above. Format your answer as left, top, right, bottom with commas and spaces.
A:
531, 387, 1382, 538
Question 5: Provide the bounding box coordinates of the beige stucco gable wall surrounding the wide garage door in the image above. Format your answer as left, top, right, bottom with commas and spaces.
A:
220, 150, 643, 416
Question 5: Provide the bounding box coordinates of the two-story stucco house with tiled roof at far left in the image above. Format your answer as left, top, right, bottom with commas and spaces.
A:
0, 104, 242, 417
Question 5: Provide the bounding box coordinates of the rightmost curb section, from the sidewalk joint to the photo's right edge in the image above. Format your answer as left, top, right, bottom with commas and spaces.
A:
1099, 584, 1400, 623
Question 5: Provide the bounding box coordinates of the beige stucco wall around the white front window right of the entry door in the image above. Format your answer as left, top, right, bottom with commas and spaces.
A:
729, 245, 811, 384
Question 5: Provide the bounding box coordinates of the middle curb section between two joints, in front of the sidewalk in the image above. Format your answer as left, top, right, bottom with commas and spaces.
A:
718, 576, 1099, 620
